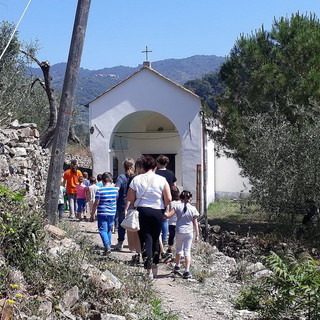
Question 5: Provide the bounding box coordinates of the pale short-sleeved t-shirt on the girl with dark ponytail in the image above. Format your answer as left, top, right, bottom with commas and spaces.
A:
170, 201, 199, 233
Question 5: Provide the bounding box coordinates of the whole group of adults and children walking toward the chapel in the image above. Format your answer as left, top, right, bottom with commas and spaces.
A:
63, 155, 199, 279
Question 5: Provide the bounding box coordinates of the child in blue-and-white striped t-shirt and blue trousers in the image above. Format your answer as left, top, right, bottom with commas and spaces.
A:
91, 172, 118, 255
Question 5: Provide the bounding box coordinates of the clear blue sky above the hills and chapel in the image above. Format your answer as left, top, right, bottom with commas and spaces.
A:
0, 0, 320, 70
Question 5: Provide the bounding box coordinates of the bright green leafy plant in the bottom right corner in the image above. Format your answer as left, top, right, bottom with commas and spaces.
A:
237, 253, 320, 320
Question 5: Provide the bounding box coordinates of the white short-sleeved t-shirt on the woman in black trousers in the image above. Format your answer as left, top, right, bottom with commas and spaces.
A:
130, 172, 168, 209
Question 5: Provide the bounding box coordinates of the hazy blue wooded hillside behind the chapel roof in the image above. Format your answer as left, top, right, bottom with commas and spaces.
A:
29, 55, 224, 105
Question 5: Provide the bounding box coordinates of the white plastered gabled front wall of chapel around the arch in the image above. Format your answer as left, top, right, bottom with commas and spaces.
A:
89, 68, 201, 199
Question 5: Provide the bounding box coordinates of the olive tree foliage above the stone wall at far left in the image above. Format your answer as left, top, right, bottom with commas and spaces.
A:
0, 22, 49, 130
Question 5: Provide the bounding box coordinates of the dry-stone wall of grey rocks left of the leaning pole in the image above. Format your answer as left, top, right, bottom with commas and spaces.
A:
0, 120, 50, 197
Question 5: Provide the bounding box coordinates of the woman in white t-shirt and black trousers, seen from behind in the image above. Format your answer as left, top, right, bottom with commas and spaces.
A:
126, 156, 171, 278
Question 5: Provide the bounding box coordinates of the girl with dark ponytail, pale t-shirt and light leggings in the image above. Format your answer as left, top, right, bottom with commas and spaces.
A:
165, 190, 199, 279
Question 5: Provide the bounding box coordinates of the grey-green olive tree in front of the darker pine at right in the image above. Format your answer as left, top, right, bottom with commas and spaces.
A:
238, 111, 320, 220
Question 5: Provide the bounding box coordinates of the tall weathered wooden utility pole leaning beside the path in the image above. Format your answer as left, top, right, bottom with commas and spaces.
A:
45, 0, 91, 225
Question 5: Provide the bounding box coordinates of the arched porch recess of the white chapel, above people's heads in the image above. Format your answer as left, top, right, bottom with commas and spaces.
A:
109, 111, 182, 185
